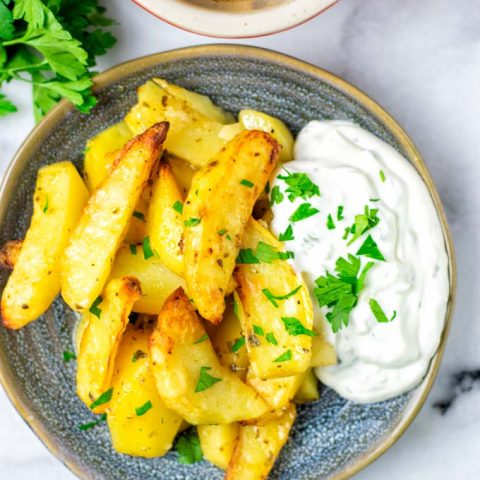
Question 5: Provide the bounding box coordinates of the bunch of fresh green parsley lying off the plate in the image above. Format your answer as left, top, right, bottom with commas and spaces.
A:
0, 0, 115, 121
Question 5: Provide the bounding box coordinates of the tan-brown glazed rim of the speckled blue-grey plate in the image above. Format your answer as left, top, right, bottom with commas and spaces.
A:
0, 44, 457, 480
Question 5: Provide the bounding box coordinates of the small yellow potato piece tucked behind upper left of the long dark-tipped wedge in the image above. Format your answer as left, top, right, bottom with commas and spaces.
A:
83, 122, 133, 192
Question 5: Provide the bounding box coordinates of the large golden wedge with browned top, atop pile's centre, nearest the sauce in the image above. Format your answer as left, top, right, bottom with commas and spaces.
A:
183, 131, 279, 324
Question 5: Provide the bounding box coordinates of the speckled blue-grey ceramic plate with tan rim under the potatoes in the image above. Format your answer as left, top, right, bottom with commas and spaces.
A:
0, 45, 455, 480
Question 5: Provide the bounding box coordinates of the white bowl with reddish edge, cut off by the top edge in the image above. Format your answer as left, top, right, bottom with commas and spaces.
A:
133, 0, 338, 38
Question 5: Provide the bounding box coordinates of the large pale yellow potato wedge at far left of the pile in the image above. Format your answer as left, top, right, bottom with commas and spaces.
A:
1, 162, 88, 329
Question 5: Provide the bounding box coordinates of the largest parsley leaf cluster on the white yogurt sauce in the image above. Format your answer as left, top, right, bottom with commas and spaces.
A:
314, 254, 374, 333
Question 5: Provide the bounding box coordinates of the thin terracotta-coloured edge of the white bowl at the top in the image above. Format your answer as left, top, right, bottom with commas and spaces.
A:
132, 0, 340, 40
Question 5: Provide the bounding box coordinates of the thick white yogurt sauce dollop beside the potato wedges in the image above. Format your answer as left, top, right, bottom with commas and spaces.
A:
271, 121, 449, 403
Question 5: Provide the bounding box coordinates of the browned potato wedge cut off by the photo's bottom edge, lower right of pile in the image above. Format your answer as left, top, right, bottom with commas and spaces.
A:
225, 404, 296, 480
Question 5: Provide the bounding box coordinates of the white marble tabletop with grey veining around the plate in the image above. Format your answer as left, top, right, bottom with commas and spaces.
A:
0, 0, 480, 480
